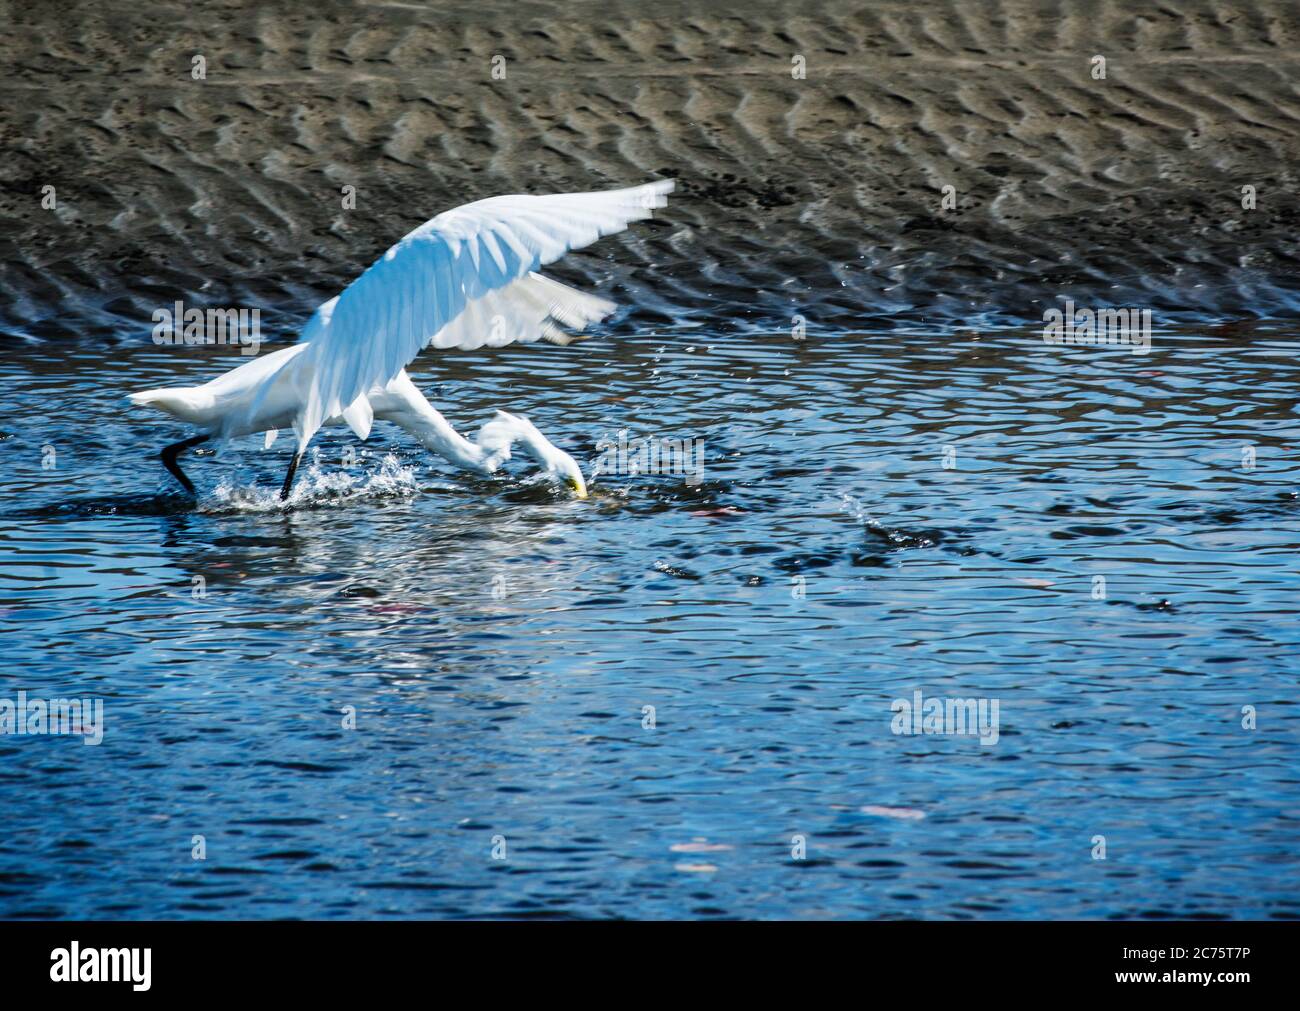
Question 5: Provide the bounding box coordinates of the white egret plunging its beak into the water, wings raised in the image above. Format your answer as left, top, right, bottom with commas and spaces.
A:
129, 181, 673, 499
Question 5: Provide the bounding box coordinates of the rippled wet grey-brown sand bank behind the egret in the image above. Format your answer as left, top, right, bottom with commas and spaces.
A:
0, 0, 1300, 342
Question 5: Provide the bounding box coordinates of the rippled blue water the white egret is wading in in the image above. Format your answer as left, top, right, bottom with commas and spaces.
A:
0, 326, 1300, 917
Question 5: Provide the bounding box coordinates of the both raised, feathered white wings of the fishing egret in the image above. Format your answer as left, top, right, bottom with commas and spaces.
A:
291, 181, 673, 443
